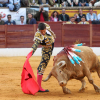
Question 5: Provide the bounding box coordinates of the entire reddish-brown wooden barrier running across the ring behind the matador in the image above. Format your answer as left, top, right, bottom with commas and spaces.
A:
0, 22, 100, 48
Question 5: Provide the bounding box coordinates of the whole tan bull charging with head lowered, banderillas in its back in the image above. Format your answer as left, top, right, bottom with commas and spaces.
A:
43, 46, 100, 94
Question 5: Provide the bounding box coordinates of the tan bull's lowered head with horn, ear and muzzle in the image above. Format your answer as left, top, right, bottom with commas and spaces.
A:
43, 61, 68, 86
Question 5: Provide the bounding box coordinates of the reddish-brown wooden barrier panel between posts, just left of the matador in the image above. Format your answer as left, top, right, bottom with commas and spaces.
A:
6, 25, 36, 48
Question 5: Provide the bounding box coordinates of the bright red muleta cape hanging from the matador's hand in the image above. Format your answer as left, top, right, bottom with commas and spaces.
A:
21, 51, 39, 95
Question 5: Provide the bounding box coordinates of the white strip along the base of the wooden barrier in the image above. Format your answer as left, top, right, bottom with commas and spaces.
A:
0, 47, 100, 57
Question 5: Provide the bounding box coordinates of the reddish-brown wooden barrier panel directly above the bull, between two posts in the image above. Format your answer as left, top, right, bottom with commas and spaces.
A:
62, 24, 90, 46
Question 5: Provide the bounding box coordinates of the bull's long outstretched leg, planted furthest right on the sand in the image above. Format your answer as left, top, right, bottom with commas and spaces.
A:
84, 68, 100, 93
